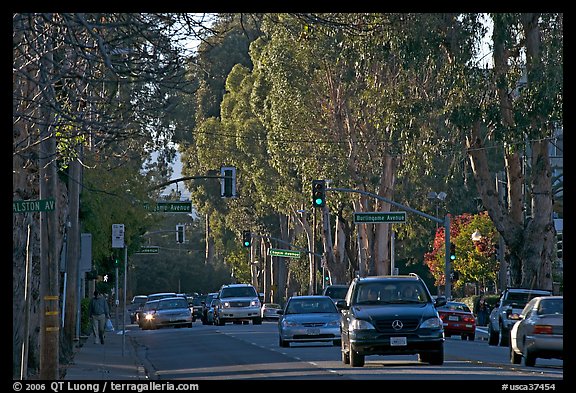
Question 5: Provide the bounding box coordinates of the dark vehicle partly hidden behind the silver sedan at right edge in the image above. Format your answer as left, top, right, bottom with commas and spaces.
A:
488, 288, 552, 347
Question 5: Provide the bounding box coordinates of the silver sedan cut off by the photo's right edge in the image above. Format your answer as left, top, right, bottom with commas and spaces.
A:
508, 296, 564, 367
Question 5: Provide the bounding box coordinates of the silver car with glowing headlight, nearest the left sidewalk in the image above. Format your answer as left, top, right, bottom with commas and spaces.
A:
142, 296, 192, 330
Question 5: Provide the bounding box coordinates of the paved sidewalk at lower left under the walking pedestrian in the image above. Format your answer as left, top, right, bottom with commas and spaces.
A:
63, 330, 148, 381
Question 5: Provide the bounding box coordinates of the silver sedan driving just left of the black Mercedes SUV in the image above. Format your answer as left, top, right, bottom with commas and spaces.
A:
278, 295, 341, 348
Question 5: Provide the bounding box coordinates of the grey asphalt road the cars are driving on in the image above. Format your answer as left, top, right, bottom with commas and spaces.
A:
130, 321, 564, 382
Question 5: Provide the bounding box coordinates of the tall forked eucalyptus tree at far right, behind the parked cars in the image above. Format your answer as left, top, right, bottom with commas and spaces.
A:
438, 13, 563, 289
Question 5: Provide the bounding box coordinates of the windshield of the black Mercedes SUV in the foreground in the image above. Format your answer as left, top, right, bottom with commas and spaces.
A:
355, 282, 429, 305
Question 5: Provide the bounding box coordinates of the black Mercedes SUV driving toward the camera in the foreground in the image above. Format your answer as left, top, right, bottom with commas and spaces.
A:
336, 273, 446, 367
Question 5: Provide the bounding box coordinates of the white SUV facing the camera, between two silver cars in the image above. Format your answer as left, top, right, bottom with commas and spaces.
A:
214, 284, 262, 326
